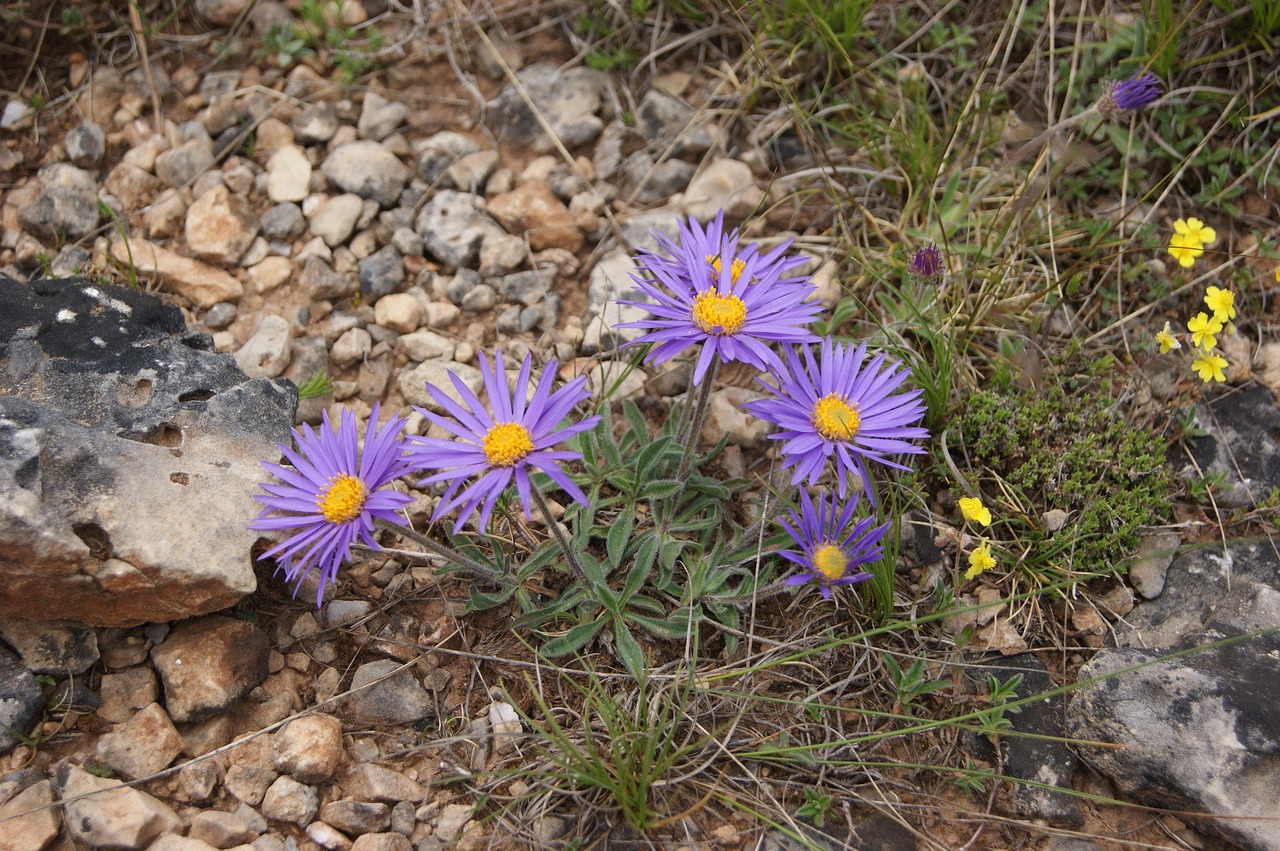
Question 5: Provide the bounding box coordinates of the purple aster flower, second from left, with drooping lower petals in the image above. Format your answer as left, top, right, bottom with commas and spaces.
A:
408, 352, 600, 534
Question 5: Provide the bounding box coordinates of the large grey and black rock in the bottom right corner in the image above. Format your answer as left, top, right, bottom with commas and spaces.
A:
1068, 621, 1280, 851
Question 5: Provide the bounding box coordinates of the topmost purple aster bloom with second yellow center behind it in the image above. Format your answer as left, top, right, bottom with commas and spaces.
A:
621, 211, 822, 384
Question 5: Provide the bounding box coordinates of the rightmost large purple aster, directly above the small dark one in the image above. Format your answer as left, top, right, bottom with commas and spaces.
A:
742, 338, 929, 504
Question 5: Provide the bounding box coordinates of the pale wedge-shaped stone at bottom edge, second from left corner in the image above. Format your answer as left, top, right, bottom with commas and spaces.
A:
58, 765, 182, 848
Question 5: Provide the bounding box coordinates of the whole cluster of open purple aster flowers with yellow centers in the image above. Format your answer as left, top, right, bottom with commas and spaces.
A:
251, 212, 941, 611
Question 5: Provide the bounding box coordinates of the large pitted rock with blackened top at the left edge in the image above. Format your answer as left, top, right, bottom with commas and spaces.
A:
0, 279, 294, 626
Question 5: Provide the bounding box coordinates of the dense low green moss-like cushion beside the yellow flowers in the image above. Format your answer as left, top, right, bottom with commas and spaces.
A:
956, 385, 1174, 582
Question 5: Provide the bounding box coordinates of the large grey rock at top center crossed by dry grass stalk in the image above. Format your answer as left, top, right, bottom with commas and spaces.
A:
489, 63, 605, 154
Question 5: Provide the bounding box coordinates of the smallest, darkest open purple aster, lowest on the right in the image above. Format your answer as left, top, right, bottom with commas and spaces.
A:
778, 490, 888, 600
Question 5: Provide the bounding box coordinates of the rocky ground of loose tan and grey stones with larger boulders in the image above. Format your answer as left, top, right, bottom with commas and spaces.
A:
0, 1, 1280, 851
